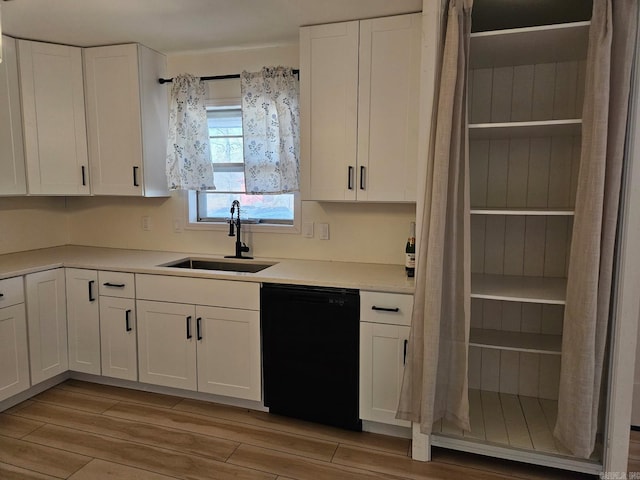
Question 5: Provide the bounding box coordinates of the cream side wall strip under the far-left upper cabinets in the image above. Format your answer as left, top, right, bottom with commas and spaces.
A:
0, 197, 69, 254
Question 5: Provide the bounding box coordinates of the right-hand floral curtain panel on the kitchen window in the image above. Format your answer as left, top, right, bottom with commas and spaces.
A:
240, 67, 300, 194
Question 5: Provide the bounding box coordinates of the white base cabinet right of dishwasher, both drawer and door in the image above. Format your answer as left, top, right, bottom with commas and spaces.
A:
360, 291, 413, 427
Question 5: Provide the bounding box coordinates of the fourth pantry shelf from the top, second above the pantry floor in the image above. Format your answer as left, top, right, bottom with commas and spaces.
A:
471, 273, 567, 305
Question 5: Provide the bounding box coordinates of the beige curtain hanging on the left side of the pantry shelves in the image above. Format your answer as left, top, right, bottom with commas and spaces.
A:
397, 0, 473, 433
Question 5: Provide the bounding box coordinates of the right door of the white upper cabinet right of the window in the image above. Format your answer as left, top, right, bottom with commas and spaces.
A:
357, 13, 422, 202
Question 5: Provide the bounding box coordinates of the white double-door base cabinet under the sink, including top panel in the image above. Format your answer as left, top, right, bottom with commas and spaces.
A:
136, 275, 262, 401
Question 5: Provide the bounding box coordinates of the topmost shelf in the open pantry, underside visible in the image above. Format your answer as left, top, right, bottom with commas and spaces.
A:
469, 22, 591, 69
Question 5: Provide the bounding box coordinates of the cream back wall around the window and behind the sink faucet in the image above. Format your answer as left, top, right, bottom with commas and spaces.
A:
63, 45, 415, 264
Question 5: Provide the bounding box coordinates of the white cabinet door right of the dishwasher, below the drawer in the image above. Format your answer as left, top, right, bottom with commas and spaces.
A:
360, 322, 410, 427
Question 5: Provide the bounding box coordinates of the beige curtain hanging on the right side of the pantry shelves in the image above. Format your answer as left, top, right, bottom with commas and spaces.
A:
554, 0, 638, 458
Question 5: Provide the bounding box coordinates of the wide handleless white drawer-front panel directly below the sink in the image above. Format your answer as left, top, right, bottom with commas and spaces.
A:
136, 274, 260, 310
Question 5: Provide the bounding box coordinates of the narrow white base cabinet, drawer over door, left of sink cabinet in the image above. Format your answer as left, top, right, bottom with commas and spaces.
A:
98, 271, 138, 381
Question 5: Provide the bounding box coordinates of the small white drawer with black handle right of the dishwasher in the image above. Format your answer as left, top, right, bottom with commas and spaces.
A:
360, 291, 413, 325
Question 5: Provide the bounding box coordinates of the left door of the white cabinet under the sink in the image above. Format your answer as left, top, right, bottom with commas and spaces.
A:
137, 300, 198, 390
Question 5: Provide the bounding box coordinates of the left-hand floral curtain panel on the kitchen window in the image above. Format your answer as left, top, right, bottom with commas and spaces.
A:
167, 74, 216, 190
